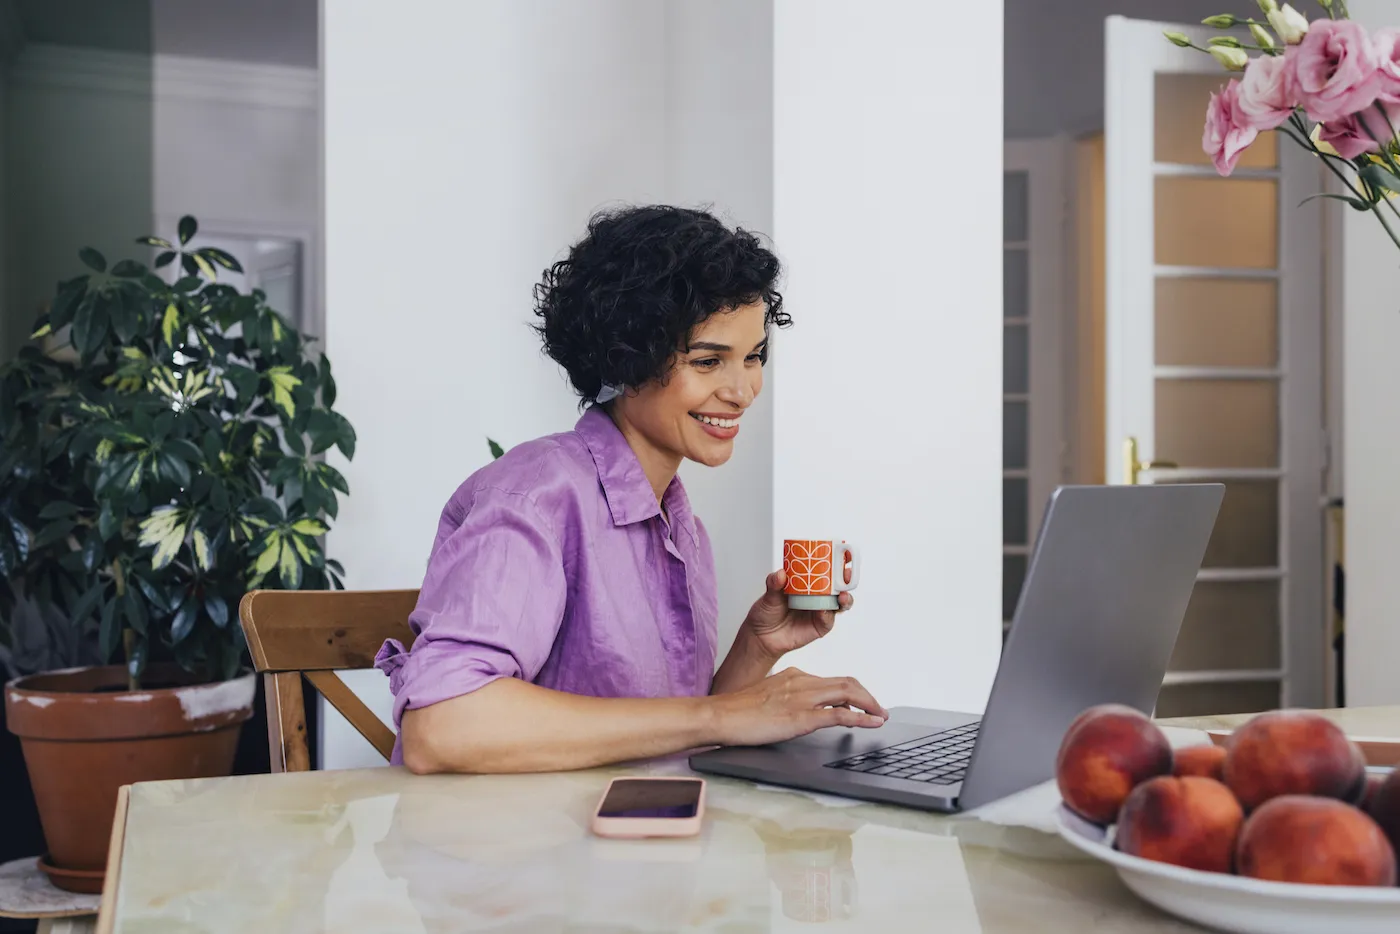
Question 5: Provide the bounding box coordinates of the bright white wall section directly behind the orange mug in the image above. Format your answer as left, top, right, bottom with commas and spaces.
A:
773, 0, 1002, 711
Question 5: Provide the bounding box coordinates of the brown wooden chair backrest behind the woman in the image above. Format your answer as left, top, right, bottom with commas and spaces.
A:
238, 590, 419, 772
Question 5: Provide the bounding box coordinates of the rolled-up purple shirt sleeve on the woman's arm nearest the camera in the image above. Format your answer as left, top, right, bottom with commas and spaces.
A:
375, 489, 568, 727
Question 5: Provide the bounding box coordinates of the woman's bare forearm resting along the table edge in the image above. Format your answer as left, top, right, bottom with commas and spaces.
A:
399, 678, 717, 773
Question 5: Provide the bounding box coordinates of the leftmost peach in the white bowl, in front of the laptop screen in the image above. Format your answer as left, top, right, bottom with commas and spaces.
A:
1056, 704, 1172, 825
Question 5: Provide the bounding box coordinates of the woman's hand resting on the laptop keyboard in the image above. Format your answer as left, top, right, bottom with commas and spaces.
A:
710, 668, 889, 746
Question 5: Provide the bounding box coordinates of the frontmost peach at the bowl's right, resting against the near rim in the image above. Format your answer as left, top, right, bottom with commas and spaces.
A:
1235, 794, 1396, 885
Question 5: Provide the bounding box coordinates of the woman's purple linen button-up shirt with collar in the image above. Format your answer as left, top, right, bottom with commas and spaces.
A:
374, 407, 718, 765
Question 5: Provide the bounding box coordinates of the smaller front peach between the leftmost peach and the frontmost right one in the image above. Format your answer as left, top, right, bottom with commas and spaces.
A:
1114, 776, 1245, 872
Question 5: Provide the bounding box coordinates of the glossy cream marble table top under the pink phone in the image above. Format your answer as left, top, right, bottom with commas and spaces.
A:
103, 707, 1400, 934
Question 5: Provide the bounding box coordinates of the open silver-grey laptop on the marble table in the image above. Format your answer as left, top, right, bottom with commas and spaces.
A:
690, 483, 1225, 811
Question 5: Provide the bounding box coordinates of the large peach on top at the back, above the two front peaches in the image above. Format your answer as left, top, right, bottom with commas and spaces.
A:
1225, 710, 1366, 811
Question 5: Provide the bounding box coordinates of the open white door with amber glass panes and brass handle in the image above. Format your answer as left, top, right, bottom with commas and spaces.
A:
1105, 17, 1327, 716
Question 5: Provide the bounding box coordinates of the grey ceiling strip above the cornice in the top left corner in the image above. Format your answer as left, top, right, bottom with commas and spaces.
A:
13, 0, 319, 67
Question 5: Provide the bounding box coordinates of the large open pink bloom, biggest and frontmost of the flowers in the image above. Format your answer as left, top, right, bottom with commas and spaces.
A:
1294, 20, 1380, 123
